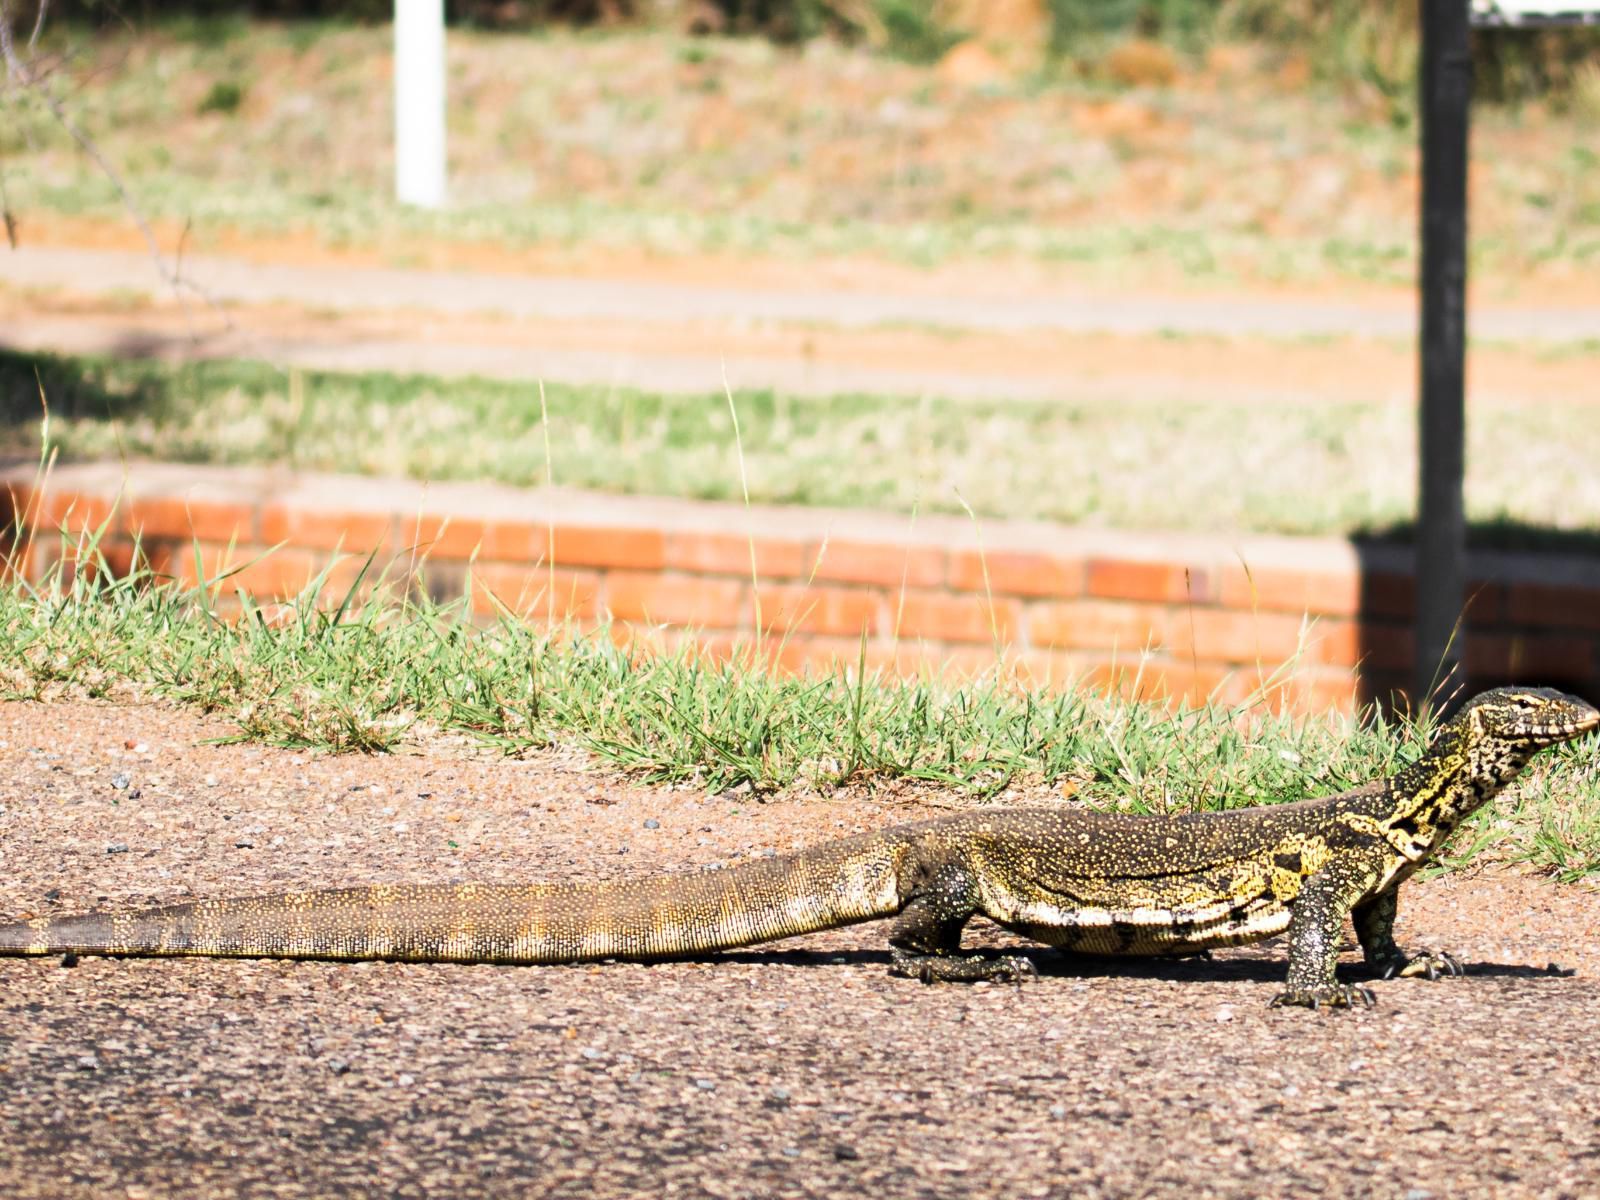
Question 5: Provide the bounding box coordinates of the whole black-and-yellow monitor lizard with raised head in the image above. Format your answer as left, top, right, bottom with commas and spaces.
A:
0, 688, 1600, 1008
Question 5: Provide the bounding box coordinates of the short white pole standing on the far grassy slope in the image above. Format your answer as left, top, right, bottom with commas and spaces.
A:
395, 0, 445, 208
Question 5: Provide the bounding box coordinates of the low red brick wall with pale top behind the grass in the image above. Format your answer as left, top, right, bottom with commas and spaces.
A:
8, 464, 1600, 706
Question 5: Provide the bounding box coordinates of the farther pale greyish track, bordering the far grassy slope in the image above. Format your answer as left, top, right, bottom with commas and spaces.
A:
12, 246, 1600, 342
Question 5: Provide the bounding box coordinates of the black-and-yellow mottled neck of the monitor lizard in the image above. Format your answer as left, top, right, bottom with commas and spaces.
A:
1386, 726, 1530, 843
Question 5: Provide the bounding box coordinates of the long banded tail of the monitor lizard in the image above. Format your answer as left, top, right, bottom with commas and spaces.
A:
0, 834, 906, 963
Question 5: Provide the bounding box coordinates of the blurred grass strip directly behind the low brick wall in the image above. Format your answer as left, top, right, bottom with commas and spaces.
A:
9, 352, 1600, 546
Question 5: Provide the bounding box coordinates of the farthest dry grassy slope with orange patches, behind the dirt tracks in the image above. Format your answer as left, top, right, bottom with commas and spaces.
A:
0, 22, 1600, 283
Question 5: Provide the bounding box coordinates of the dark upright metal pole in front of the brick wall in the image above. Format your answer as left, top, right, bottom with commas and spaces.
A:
1411, 0, 1472, 704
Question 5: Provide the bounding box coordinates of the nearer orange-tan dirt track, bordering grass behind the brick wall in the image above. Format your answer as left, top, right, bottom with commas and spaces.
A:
0, 258, 1600, 406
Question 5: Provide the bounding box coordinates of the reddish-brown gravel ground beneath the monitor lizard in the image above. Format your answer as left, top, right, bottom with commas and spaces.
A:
0, 704, 1600, 1200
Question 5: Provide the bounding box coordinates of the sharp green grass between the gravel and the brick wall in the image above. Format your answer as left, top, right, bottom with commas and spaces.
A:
0, 524, 1600, 878
